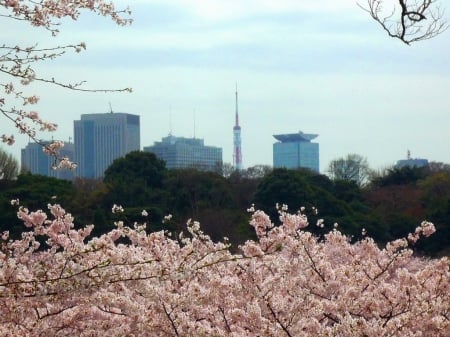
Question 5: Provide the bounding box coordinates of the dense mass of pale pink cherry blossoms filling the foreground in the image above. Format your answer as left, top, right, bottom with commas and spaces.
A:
0, 200, 450, 337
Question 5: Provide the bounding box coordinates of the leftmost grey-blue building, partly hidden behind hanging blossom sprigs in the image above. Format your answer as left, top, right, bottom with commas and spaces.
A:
20, 140, 75, 180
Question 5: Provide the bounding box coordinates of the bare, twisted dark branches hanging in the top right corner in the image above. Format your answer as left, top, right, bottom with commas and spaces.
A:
358, 0, 449, 45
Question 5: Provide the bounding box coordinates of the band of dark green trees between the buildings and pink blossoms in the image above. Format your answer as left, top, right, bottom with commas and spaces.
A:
0, 152, 450, 256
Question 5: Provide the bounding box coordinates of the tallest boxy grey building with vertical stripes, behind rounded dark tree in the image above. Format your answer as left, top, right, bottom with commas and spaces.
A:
74, 112, 140, 178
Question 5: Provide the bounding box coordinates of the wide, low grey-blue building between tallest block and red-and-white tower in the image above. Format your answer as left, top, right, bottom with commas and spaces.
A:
144, 135, 222, 171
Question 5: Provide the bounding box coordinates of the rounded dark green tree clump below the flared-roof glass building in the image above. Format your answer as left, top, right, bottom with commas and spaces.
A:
255, 169, 387, 242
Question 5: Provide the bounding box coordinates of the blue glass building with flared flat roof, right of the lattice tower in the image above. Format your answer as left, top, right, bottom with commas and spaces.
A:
273, 131, 319, 172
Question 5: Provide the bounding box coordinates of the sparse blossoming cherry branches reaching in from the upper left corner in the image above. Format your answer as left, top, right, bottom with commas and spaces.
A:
0, 0, 131, 168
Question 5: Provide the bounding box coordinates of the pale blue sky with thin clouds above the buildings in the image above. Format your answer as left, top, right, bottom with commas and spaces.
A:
0, 0, 450, 173
